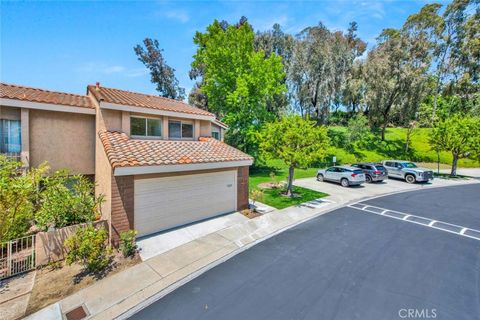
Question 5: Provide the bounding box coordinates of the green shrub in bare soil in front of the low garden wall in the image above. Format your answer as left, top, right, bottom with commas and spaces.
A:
64, 225, 111, 272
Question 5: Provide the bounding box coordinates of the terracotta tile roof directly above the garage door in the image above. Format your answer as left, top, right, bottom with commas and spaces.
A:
99, 131, 253, 168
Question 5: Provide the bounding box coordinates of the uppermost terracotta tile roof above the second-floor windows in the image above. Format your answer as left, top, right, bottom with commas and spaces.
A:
88, 85, 214, 117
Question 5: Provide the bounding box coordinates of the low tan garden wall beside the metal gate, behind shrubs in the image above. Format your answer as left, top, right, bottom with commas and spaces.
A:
35, 220, 108, 267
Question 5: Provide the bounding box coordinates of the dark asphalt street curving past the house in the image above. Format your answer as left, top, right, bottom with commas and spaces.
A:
132, 184, 480, 320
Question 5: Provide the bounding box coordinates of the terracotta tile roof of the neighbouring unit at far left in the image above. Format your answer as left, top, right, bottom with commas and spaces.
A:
0, 83, 95, 109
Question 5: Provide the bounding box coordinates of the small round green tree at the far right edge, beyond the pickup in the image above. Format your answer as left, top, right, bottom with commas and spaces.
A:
430, 115, 480, 176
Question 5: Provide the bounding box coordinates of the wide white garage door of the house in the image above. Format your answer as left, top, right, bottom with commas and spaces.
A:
134, 171, 237, 236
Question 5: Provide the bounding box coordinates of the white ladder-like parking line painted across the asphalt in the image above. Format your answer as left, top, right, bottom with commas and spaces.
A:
347, 202, 480, 240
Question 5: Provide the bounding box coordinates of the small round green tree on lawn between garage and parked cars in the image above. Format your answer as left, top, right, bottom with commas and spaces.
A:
259, 115, 329, 197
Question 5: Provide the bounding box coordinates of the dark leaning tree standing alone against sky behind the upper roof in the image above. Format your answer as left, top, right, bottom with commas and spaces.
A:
133, 38, 185, 100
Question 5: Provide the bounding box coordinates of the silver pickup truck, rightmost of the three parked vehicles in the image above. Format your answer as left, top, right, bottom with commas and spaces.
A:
382, 160, 433, 183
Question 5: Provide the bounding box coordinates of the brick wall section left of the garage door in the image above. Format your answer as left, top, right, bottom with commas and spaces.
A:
110, 175, 134, 246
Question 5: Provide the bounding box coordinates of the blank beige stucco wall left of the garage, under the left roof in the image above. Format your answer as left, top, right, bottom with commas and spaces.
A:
29, 109, 95, 174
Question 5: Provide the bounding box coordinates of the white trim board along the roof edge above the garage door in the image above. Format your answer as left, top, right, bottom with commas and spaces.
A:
114, 160, 253, 176
